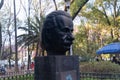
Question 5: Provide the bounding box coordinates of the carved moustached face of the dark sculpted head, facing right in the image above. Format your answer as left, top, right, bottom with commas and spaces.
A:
53, 15, 74, 51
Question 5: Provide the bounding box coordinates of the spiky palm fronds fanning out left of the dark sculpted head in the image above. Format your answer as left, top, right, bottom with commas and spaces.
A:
17, 17, 44, 46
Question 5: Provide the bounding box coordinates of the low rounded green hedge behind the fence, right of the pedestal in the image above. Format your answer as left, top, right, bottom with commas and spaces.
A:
80, 61, 120, 73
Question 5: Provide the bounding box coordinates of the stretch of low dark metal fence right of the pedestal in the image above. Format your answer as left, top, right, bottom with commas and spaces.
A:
80, 72, 120, 80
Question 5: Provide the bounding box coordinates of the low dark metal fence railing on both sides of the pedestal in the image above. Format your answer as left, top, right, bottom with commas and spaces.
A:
0, 72, 120, 80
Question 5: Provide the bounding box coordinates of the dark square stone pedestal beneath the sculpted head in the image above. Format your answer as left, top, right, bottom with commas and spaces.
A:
35, 56, 80, 80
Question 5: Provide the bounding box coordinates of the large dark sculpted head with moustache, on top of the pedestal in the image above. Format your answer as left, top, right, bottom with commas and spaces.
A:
42, 10, 74, 55
